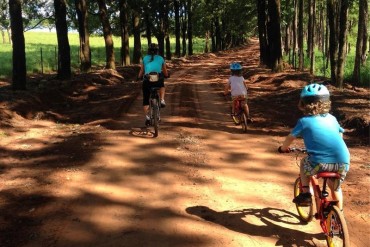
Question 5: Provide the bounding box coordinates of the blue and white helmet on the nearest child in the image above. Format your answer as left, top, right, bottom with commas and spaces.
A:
301, 83, 330, 104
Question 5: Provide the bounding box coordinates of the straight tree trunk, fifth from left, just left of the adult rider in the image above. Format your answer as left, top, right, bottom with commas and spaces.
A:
120, 0, 131, 66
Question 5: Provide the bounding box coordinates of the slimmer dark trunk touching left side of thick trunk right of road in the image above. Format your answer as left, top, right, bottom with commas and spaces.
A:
257, 0, 269, 65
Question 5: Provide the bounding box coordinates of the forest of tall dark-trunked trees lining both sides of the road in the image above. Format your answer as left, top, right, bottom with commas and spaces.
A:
0, 0, 370, 90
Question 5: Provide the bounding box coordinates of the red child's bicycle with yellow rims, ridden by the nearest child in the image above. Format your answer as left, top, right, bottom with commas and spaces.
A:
279, 148, 350, 247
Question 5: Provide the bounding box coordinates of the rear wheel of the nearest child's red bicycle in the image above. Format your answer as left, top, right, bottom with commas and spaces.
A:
326, 206, 350, 247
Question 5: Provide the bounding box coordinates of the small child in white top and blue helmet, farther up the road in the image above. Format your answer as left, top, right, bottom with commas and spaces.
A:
224, 62, 251, 121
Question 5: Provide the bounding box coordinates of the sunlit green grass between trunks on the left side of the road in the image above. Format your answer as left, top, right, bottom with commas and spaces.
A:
0, 32, 204, 78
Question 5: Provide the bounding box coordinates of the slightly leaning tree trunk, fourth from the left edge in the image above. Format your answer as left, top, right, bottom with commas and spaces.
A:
98, 0, 116, 69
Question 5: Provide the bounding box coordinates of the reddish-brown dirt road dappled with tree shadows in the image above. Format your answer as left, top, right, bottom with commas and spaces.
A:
0, 39, 370, 247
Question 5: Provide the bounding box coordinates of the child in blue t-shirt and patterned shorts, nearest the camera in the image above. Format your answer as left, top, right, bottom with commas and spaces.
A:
279, 83, 350, 210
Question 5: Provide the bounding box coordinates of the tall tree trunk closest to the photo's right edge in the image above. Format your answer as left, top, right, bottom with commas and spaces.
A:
353, 0, 368, 85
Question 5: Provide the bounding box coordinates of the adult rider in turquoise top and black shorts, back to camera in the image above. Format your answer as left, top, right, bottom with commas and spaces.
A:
138, 43, 169, 125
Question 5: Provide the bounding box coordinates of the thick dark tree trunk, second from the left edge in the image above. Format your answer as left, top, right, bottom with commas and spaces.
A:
54, 0, 71, 79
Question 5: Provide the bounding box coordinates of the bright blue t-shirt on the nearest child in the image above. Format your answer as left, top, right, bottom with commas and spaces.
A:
291, 113, 350, 164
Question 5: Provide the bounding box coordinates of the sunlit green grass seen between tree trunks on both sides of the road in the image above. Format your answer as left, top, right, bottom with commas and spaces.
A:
0, 32, 370, 86
